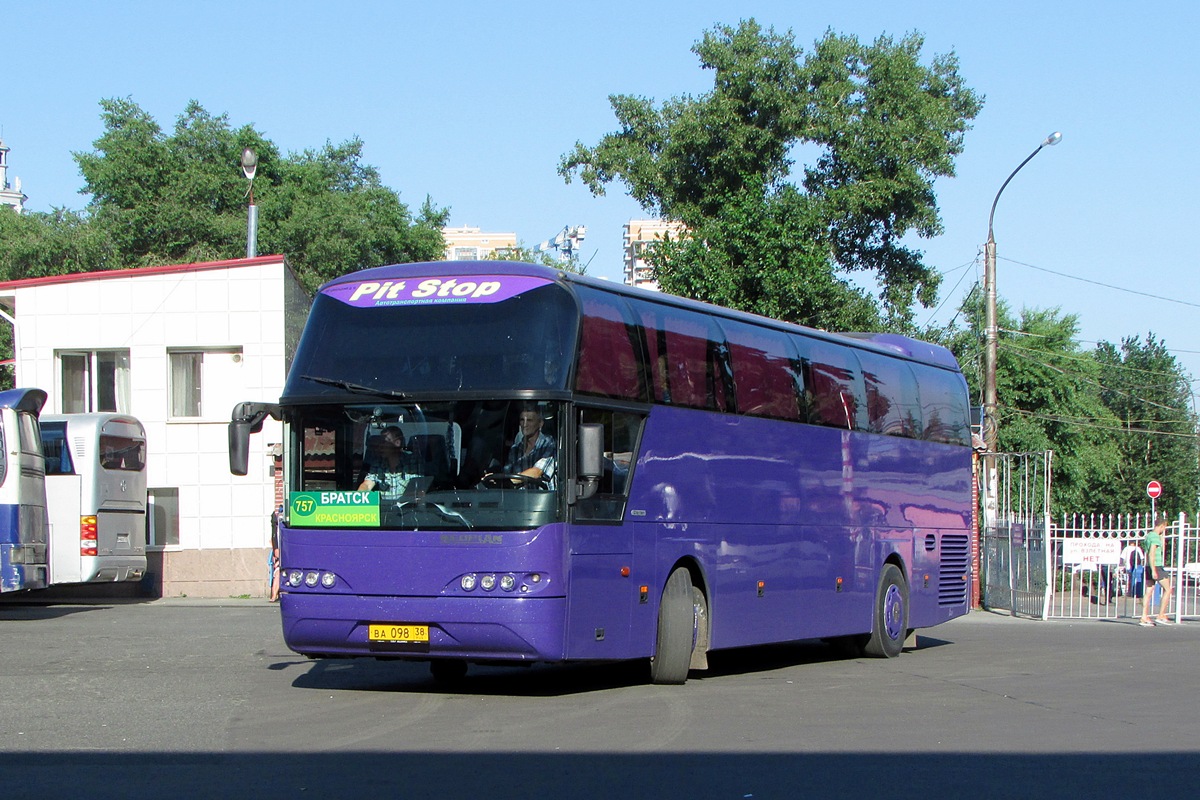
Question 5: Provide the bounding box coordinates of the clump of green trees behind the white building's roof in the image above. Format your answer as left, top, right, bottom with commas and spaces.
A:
0, 98, 448, 290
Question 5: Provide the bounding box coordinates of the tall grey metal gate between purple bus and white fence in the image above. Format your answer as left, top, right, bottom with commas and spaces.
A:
980, 451, 1054, 619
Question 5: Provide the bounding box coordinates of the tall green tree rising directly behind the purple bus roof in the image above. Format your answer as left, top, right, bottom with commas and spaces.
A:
559, 19, 982, 329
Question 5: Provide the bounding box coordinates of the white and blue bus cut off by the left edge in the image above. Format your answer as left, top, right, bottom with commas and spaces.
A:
0, 389, 49, 591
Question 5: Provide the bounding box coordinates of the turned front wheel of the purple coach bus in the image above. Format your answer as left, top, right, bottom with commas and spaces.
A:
650, 563, 710, 684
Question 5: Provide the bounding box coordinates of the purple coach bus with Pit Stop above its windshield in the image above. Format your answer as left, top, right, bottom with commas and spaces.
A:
229, 261, 972, 684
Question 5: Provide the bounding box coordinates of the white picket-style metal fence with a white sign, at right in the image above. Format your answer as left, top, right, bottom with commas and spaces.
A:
1045, 515, 1200, 621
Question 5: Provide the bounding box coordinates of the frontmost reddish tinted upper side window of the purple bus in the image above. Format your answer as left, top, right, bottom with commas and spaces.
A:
575, 287, 647, 401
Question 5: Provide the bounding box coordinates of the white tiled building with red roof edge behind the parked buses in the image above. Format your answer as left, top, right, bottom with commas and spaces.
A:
0, 255, 310, 597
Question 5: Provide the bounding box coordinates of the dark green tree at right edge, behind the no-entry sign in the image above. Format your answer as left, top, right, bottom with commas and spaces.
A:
1094, 333, 1200, 511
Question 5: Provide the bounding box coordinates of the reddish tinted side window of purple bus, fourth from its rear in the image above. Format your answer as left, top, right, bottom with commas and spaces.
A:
721, 319, 804, 421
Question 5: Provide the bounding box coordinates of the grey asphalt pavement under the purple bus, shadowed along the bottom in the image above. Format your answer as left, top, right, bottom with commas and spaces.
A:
0, 597, 1200, 799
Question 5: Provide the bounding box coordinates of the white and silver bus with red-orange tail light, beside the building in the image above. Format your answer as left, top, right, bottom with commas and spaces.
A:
41, 414, 146, 584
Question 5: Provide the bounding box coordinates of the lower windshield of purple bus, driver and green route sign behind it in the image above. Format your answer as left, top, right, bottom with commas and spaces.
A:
289, 399, 563, 530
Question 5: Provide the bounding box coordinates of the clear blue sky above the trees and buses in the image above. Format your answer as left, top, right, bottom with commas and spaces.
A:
7, 0, 1200, 388
